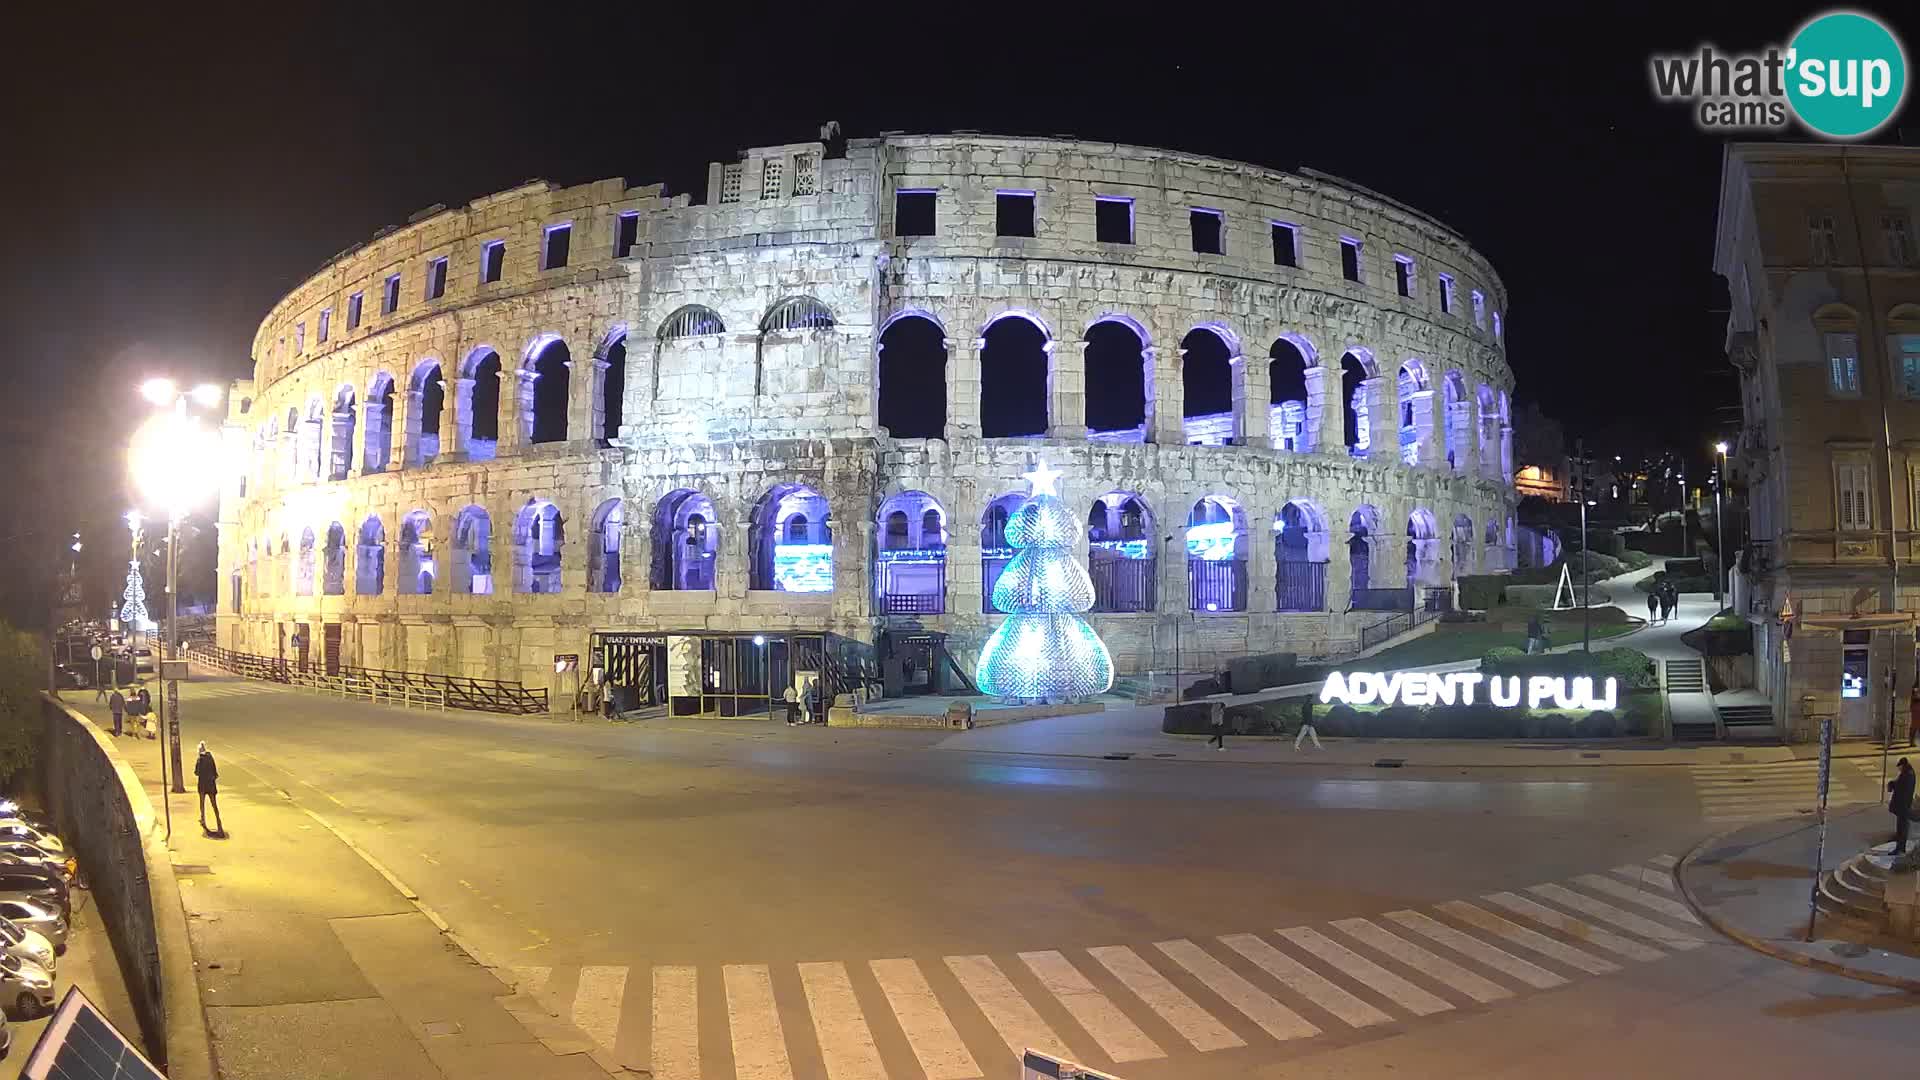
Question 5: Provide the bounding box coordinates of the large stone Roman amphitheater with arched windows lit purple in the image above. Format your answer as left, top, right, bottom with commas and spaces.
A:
217, 131, 1515, 715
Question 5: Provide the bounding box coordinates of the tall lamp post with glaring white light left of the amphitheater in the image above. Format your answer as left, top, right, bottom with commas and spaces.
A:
127, 379, 221, 795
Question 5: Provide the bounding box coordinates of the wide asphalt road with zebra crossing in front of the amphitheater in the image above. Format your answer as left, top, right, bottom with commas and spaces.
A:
165, 682, 1920, 1080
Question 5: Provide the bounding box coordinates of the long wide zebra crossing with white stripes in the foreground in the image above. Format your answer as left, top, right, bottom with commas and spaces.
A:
511, 855, 1707, 1080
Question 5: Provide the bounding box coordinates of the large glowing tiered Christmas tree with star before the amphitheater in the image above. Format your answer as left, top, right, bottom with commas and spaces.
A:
977, 463, 1114, 703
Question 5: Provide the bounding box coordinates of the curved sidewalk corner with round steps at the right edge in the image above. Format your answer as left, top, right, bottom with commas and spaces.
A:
1678, 805, 1920, 994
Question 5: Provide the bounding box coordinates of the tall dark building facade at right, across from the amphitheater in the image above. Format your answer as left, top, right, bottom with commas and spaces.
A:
1715, 144, 1920, 740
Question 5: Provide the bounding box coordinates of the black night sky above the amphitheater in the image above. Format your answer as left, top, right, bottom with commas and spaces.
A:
0, 4, 1920, 622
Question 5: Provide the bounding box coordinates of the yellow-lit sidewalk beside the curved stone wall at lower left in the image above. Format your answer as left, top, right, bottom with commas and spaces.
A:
79, 703, 609, 1080
